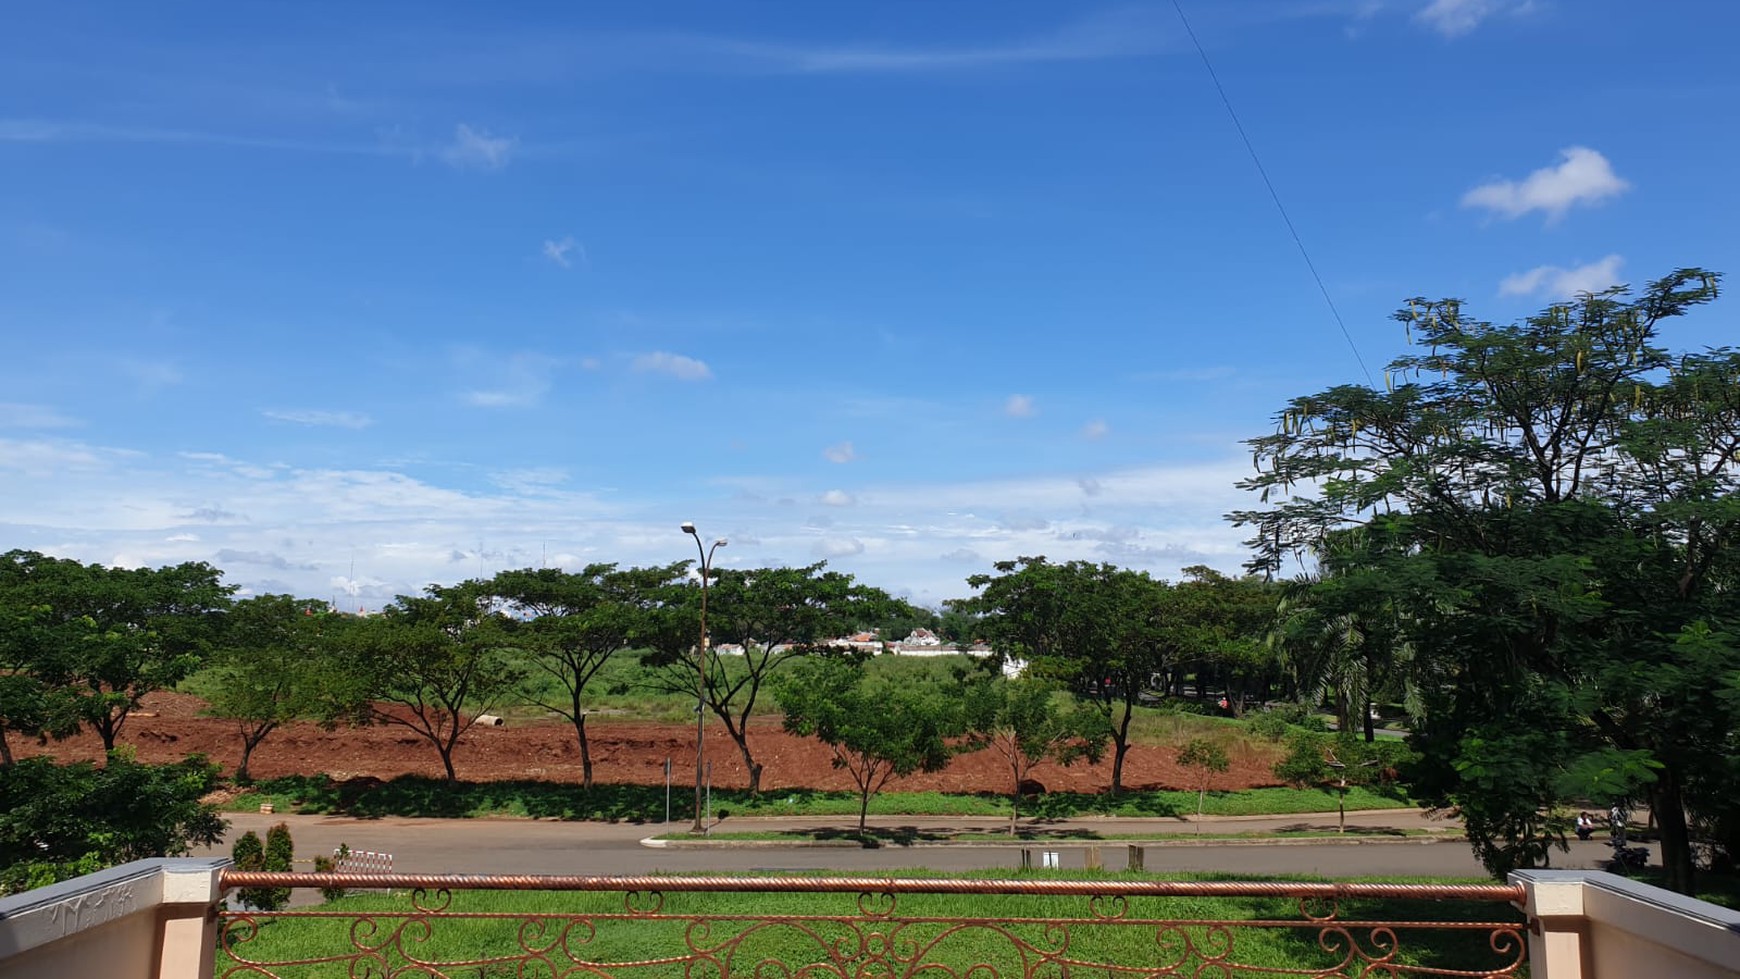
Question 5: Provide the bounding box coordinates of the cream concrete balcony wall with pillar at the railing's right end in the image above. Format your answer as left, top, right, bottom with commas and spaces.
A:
1510, 871, 1740, 979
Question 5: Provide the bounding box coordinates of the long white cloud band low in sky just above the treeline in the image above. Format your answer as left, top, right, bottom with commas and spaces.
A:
0, 427, 1255, 610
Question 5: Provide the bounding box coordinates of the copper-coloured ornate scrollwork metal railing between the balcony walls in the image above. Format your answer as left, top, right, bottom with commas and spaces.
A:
216, 871, 1526, 979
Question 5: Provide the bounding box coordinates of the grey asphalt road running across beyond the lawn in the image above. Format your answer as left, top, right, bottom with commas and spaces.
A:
205, 812, 1610, 878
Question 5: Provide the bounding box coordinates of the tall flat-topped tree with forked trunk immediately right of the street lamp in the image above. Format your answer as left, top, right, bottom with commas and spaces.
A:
646, 563, 894, 795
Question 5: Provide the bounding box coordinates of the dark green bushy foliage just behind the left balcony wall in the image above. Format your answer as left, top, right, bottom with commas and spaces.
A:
0, 751, 224, 890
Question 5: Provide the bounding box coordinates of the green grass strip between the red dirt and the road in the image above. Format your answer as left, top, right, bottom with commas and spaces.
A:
230, 776, 1409, 822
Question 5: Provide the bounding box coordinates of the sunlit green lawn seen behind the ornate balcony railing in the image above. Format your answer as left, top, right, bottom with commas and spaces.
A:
216, 871, 1521, 979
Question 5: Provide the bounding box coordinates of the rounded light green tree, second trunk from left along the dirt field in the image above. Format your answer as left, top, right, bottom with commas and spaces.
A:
205, 595, 355, 783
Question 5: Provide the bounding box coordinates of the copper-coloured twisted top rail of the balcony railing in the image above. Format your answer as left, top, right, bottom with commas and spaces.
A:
221, 869, 1523, 902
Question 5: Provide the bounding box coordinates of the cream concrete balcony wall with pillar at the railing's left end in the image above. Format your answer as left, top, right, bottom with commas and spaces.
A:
0, 859, 230, 979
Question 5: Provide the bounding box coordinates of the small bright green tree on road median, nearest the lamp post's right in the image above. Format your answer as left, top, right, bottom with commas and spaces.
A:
774, 659, 960, 833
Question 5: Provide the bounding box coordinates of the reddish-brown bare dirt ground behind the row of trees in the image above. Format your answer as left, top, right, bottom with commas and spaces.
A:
14, 692, 1279, 793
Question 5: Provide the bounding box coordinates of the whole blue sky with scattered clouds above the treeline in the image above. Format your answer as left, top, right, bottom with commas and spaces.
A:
0, 0, 1740, 607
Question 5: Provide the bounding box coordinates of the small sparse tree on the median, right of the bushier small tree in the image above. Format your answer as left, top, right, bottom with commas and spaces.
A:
960, 676, 1107, 836
